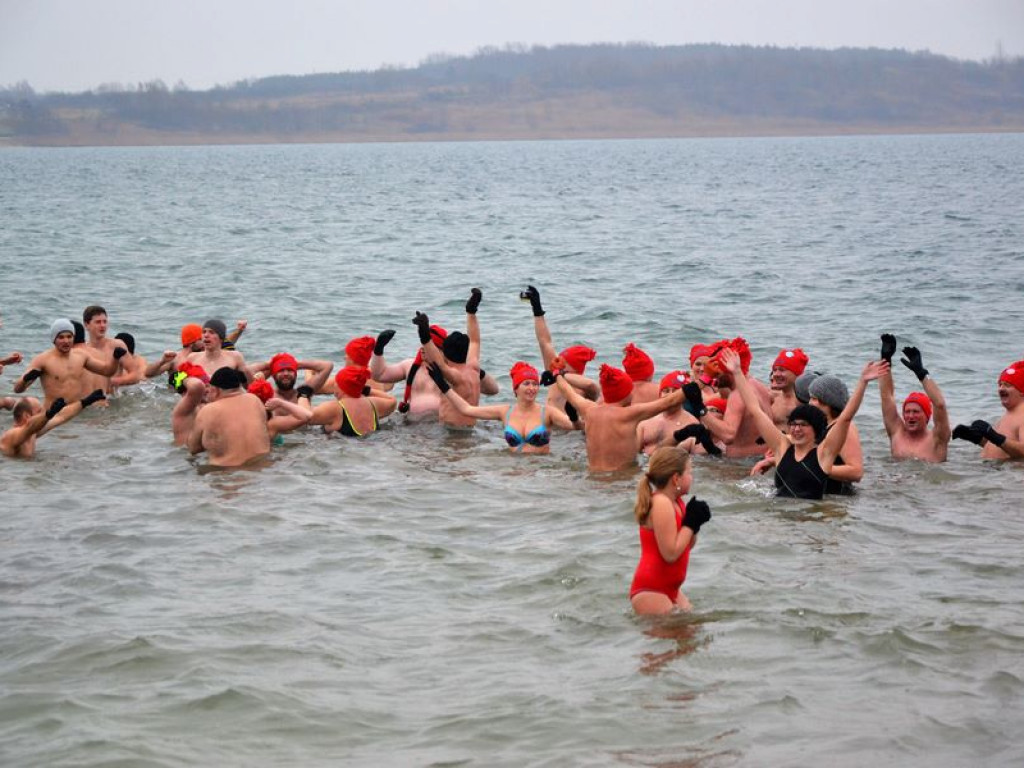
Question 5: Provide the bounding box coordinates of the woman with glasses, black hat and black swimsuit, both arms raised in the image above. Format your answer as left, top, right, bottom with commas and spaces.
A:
722, 349, 889, 499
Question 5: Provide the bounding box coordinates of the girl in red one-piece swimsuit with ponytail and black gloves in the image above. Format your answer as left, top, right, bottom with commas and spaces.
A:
630, 447, 711, 614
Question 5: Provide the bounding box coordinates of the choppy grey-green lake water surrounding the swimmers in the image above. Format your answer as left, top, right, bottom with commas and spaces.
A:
0, 135, 1024, 766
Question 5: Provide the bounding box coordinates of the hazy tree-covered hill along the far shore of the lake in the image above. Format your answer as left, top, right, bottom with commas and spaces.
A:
0, 44, 1024, 143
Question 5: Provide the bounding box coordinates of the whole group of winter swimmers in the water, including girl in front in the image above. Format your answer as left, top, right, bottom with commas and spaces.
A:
0, 286, 1024, 613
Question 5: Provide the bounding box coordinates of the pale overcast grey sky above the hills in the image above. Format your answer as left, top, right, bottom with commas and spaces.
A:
0, 0, 1024, 91
